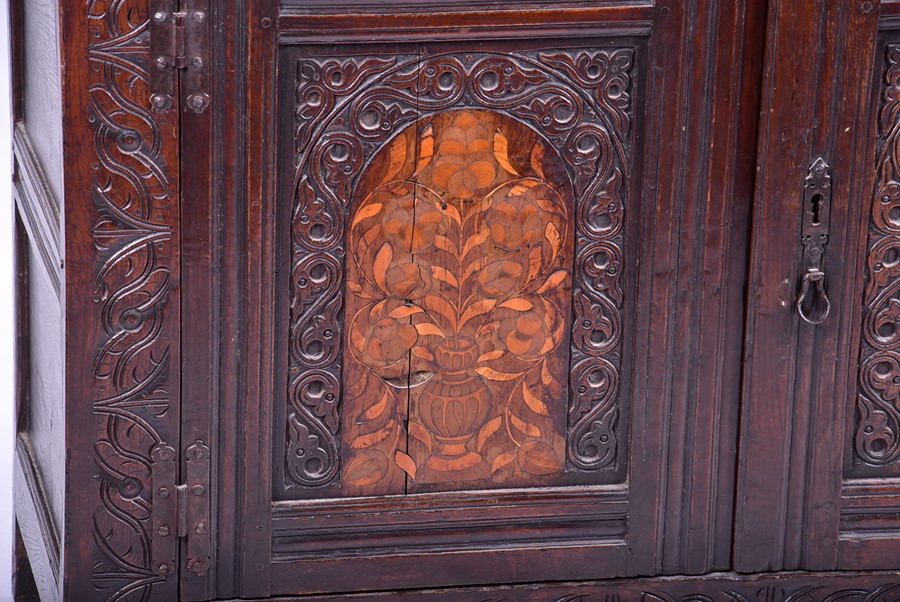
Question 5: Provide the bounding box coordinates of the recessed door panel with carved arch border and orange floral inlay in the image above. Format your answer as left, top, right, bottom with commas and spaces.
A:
276, 42, 635, 498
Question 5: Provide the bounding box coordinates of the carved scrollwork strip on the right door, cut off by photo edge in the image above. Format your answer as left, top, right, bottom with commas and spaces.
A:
854, 46, 900, 474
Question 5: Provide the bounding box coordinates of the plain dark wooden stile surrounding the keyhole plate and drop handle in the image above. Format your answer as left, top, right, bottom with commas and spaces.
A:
735, 2, 884, 571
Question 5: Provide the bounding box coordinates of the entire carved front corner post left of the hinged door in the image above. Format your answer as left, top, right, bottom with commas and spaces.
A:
56, 0, 181, 599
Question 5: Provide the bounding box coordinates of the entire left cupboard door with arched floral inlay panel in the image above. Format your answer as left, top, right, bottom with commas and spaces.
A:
182, 0, 765, 597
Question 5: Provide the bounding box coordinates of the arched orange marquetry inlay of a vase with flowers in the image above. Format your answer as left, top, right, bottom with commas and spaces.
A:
342, 110, 574, 495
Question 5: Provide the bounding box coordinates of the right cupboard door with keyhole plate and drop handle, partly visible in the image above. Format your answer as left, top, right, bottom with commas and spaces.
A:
735, 1, 900, 572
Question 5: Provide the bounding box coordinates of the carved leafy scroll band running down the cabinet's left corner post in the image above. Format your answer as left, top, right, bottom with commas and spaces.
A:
86, 0, 178, 600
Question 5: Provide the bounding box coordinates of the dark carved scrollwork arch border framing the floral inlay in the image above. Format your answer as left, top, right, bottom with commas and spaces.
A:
284, 48, 634, 489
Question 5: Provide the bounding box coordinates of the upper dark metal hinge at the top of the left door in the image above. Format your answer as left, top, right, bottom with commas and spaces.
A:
147, 0, 209, 113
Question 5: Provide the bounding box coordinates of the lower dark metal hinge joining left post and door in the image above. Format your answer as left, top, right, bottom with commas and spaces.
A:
150, 439, 212, 577
